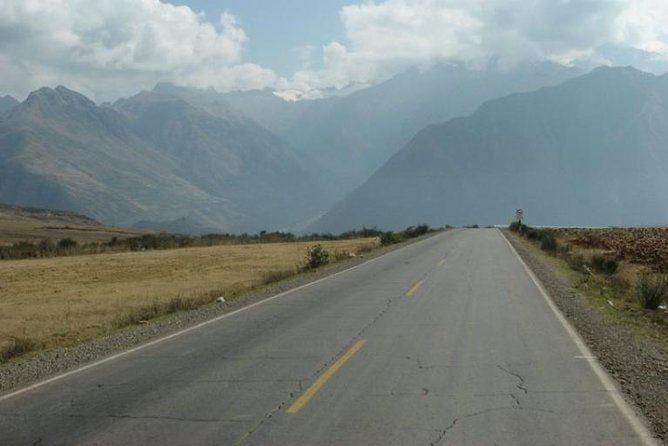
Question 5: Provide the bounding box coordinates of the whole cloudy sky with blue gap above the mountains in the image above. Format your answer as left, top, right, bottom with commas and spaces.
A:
0, 0, 668, 101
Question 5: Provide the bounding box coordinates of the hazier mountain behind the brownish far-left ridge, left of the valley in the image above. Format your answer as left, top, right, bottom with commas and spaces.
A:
114, 92, 334, 231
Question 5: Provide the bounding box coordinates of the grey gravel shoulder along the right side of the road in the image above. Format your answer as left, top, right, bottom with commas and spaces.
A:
504, 231, 668, 444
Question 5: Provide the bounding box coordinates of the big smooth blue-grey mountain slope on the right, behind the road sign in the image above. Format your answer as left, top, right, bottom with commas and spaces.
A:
310, 68, 668, 231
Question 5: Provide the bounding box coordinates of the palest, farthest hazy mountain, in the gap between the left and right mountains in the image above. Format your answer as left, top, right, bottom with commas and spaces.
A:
222, 63, 582, 197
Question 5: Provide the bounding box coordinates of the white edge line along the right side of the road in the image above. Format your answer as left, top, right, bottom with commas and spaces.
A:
497, 228, 658, 446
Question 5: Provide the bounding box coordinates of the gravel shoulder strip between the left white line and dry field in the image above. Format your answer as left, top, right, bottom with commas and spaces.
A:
0, 232, 439, 396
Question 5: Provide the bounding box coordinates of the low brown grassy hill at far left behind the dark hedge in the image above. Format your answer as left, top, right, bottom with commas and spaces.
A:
0, 204, 152, 246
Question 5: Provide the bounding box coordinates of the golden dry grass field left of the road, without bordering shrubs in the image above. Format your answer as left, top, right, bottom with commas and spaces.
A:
0, 238, 378, 359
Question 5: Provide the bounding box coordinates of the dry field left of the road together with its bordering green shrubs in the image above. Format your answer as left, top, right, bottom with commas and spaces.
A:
0, 225, 440, 363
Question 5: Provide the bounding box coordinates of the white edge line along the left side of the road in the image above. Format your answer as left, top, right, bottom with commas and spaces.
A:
0, 231, 447, 401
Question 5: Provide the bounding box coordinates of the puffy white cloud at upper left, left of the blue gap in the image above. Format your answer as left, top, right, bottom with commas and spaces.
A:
0, 0, 275, 99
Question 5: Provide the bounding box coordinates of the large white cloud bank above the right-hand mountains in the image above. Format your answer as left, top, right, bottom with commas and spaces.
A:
279, 0, 668, 95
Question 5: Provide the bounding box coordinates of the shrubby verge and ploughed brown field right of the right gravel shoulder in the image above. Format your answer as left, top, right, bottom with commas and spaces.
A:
509, 222, 668, 345
